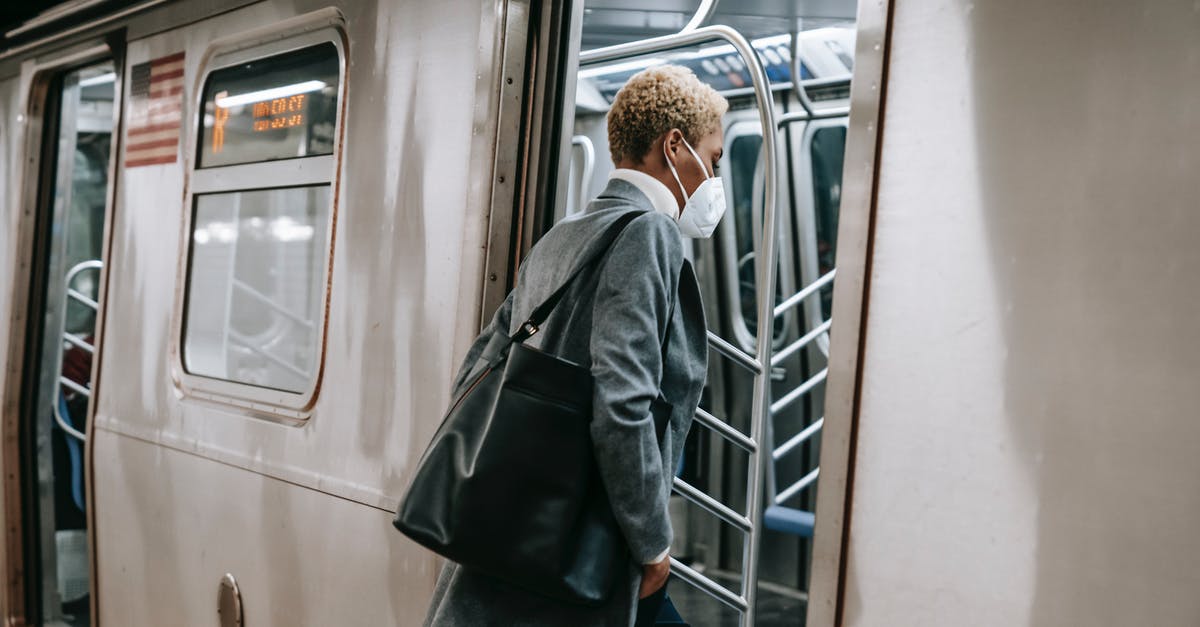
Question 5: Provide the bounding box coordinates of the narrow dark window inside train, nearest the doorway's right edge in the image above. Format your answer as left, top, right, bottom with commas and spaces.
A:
811, 125, 846, 320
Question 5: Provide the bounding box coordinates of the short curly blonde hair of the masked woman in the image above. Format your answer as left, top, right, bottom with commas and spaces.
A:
608, 65, 730, 163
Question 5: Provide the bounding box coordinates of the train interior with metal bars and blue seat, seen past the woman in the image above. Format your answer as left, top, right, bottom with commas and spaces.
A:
556, 0, 856, 626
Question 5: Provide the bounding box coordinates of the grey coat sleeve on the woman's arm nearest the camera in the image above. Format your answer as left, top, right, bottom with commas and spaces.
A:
590, 213, 683, 563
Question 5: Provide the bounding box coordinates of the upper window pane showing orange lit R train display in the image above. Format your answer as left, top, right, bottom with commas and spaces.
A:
198, 43, 338, 168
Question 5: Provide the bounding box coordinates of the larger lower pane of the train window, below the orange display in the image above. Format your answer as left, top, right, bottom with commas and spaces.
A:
182, 185, 330, 393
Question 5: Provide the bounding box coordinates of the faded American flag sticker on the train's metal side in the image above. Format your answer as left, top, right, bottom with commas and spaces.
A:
125, 53, 184, 168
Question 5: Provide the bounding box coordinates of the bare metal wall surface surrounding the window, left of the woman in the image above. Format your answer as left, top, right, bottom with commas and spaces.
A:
84, 0, 509, 625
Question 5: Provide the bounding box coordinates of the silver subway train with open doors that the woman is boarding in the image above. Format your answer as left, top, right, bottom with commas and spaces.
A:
0, 0, 1200, 627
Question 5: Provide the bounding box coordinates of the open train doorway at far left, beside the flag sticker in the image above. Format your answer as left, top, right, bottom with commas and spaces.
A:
0, 41, 121, 626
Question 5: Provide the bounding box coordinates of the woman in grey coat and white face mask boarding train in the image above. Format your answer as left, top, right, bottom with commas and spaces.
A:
425, 66, 728, 627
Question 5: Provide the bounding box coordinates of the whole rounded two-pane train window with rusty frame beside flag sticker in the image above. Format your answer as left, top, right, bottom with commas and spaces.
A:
178, 32, 344, 417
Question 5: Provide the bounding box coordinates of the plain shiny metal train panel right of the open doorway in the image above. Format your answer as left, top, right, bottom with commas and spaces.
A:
840, 0, 1200, 627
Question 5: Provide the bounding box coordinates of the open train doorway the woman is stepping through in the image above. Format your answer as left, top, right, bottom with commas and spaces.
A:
557, 1, 854, 625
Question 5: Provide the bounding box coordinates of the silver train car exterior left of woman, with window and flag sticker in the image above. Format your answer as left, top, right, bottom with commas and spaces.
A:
0, 1, 580, 625
